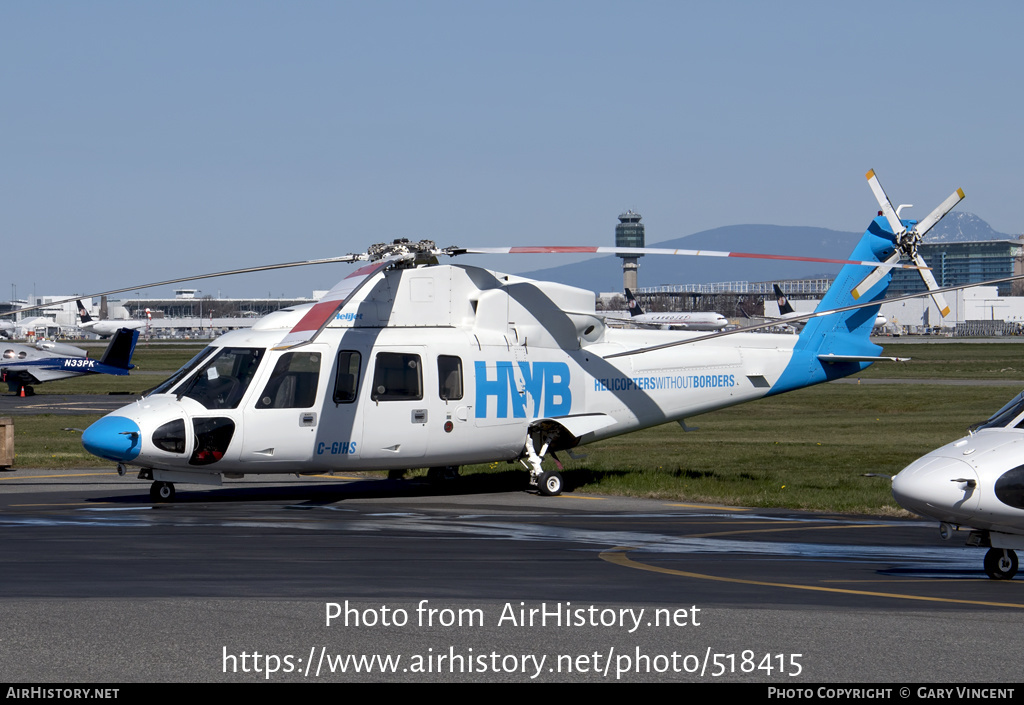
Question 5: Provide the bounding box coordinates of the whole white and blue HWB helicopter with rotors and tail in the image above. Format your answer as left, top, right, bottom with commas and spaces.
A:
74, 172, 963, 502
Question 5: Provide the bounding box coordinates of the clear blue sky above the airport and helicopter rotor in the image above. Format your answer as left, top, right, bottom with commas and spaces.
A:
0, 0, 1024, 298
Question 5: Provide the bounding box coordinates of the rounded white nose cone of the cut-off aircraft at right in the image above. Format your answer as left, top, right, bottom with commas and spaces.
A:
893, 455, 981, 524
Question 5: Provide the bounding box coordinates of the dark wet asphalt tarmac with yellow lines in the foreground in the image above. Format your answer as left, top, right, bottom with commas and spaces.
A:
0, 469, 1024, 687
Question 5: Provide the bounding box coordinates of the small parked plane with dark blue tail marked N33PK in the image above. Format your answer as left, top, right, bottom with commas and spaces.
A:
0, 328, 138, 397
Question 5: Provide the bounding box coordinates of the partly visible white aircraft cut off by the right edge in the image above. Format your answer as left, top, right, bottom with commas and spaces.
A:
892, 391, 1024, 580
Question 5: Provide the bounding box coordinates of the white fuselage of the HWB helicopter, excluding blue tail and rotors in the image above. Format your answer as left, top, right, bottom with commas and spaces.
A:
84, 265, 797, 484
